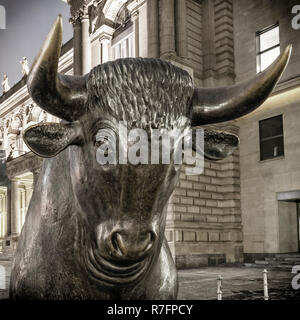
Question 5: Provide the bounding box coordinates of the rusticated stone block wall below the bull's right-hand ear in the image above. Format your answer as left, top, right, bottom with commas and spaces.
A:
166, 125, 243, 268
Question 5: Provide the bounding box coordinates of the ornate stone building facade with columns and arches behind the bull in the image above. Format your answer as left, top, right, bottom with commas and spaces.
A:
0, 0, 300, 268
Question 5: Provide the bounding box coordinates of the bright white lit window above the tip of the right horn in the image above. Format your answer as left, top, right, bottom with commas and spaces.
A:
256, 24, 280, 73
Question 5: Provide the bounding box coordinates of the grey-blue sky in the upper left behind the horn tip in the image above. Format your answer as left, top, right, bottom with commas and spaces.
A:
0, 0, 73, 95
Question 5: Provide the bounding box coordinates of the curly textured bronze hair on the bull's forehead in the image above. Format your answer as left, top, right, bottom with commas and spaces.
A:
87, 58, 193, 129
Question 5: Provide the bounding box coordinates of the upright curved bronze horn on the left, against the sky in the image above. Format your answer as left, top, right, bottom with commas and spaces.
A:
27, 15, 87, 121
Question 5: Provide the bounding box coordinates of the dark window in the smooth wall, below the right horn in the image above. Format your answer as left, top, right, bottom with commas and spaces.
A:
259, 115, 284, 160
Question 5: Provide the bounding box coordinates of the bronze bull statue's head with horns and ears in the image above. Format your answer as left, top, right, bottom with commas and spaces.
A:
24, 16, 291, 284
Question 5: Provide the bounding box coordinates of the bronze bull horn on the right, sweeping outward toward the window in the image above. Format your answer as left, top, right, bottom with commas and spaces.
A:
192, 45, 292, 126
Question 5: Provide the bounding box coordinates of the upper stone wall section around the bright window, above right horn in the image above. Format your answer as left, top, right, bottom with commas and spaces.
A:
233, 0, 300, 82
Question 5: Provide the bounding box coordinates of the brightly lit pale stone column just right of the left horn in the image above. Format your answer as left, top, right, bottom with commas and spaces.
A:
81, 6, 92, 74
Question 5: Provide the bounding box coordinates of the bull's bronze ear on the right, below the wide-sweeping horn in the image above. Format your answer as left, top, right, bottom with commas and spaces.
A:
193, 129, 239, 161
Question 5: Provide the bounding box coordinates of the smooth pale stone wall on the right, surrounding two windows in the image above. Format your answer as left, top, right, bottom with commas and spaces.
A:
234, 0, 300, 261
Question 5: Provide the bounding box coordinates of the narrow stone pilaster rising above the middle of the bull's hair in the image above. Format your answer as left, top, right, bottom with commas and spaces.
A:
147, 0, 159, 58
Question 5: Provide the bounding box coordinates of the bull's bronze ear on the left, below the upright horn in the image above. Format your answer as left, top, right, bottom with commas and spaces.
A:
24, 122, 82, 158
